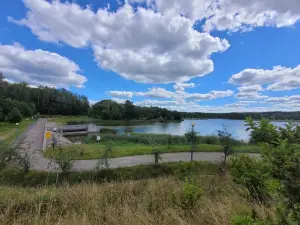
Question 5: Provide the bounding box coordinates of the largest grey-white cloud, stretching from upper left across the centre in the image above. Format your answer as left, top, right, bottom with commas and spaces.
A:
9, 0, 229, 83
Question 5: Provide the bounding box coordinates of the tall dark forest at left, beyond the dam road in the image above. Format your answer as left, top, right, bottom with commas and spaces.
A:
0, 72, 90, 122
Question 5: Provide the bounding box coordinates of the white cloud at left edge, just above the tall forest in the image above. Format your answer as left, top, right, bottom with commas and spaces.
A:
0, 43, 87, 88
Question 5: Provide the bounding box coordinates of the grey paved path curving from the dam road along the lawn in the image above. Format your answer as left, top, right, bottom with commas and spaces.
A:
25, 119, 255, 171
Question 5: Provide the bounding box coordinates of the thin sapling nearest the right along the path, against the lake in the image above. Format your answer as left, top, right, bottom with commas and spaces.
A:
217, 125, 233, 167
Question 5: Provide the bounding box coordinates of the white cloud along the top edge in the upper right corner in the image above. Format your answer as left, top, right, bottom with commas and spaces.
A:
137, 0, 300, 31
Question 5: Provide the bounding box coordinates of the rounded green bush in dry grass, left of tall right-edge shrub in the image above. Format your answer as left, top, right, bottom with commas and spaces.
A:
230, 155, 269, 201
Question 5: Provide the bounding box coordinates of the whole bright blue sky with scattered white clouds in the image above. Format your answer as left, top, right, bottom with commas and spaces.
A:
0, 0, 300, 112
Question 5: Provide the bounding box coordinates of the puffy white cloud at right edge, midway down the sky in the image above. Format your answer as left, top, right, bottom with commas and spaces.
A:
229, 65, 300, 91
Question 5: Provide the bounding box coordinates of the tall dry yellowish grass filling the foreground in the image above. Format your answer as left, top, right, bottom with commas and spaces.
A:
0, 176, 274, 225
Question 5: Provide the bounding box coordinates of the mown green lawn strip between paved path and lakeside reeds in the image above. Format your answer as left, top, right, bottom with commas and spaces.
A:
45, 141, 259, 159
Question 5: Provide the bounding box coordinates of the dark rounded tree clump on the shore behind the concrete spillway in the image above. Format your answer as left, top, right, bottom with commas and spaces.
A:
89, 100, 182, 122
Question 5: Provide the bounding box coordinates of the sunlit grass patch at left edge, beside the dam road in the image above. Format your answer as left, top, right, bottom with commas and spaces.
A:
0, 119, 34, 144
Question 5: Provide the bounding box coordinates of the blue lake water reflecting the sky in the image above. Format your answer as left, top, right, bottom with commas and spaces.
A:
99, 119, 296, 141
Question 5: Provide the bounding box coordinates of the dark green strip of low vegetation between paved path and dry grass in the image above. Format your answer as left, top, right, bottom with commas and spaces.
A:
0, 162, 217, 187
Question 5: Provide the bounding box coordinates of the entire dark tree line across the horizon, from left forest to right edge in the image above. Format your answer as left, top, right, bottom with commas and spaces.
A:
0, 72, 300, 123
